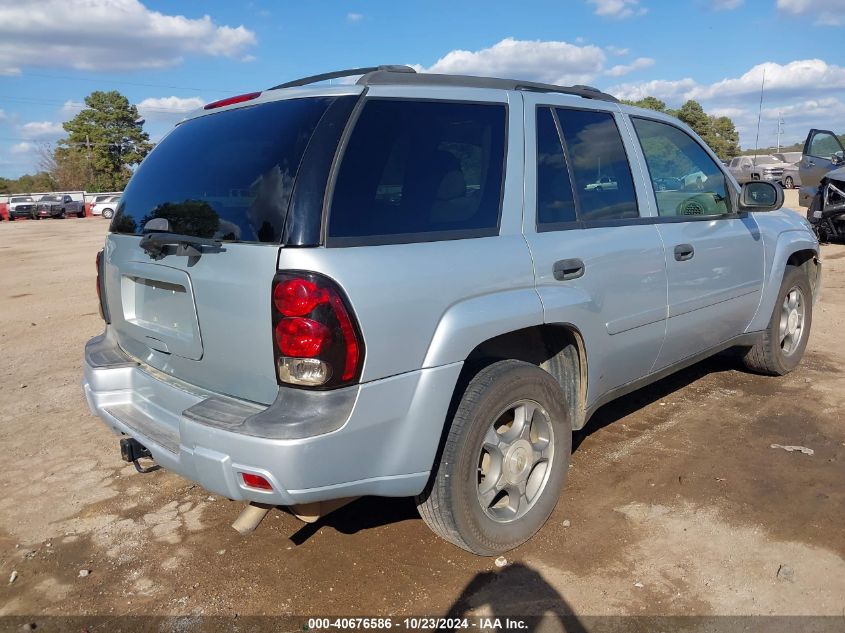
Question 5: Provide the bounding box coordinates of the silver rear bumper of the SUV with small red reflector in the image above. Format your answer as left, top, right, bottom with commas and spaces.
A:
83, 334, 461, 505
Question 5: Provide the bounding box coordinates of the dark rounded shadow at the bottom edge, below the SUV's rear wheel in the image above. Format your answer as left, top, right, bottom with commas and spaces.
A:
438, 563, 587, 633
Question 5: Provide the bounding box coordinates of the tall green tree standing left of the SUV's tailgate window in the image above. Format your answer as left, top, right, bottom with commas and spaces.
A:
56, 90, 152, 191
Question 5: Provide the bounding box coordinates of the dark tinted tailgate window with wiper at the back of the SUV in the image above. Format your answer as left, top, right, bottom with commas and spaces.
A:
111, 97, 342, 243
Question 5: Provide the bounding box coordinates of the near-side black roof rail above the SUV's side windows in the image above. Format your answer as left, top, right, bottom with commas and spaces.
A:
358, 66, 619, 103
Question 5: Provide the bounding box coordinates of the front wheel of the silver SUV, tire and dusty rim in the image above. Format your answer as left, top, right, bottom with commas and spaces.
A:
743, 266, 813, 376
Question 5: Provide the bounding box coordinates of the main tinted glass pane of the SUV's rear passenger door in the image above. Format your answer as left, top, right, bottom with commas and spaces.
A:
556, 108, 639, 222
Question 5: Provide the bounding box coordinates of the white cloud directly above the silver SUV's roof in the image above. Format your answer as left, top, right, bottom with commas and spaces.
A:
416, 37, 605, 84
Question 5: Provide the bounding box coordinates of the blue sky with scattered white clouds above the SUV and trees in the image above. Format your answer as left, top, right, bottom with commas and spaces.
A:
0, 0, 845, 177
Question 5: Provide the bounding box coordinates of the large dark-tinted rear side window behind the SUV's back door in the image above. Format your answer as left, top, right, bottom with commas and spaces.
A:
327, 99, 507, 246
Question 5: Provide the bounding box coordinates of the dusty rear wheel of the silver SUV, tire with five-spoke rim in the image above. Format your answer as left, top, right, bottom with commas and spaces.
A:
417, 360, 572, 556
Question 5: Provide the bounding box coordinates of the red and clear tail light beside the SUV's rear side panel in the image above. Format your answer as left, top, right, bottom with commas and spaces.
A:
272, 272, 364, 389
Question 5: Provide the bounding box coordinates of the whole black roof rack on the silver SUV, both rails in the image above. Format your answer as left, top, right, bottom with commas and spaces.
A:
270, 65, 618, 102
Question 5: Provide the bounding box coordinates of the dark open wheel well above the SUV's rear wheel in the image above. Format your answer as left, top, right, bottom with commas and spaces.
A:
450, 325, 587, 430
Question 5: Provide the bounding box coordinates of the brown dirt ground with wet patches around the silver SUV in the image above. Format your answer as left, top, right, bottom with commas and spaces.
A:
0, 192, 845, 628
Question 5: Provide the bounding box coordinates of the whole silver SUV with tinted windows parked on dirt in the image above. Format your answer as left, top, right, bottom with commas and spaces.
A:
84, 67, 820, 555
